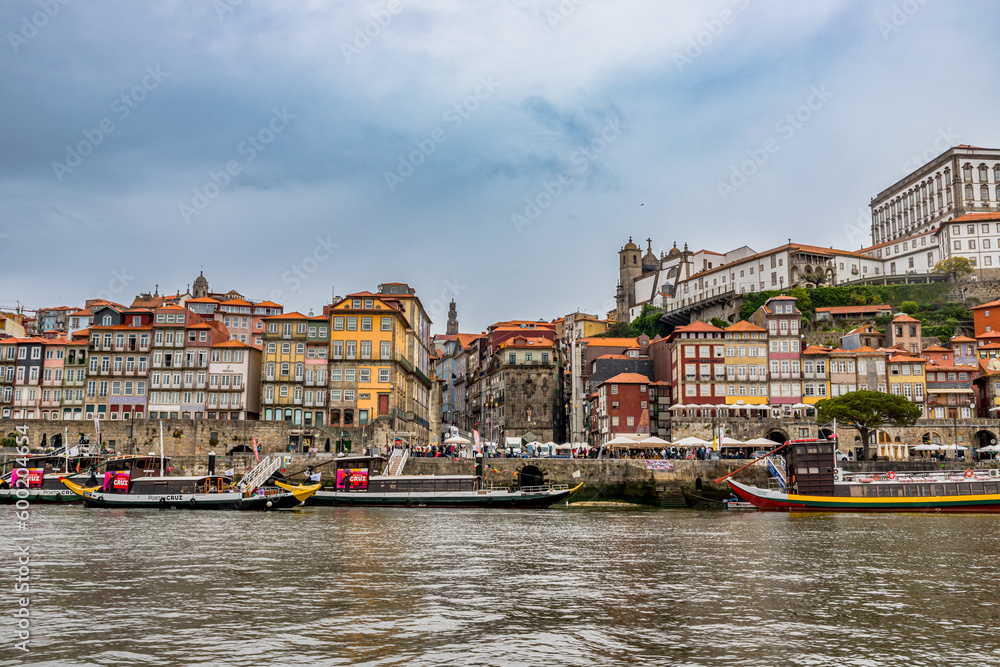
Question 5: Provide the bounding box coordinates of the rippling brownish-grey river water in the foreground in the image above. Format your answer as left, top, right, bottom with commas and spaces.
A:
0, 506, 1000, 666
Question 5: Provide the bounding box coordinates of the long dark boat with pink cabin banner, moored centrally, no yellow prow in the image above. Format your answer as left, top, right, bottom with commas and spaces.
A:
306, 456, 583, 509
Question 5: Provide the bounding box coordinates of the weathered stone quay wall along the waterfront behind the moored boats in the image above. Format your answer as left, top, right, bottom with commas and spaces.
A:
0, 419, 996, 505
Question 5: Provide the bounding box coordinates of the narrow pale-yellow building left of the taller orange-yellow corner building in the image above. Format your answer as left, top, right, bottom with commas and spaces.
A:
261, 313, 306, 426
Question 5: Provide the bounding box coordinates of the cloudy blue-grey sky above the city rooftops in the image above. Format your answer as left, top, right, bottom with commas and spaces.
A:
0, 0, 1000, 332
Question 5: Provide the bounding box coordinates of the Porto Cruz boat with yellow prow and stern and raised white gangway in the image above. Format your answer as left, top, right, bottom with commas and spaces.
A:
62, 457, 320, 510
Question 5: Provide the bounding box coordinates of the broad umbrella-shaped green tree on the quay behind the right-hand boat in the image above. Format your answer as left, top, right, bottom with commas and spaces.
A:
816, 391, 923, 460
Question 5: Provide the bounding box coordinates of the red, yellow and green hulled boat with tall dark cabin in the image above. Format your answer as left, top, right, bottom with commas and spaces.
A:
715, 440, 1000, 512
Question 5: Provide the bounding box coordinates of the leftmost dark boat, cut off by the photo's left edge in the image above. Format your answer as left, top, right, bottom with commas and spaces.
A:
0, 453, 160, 504
